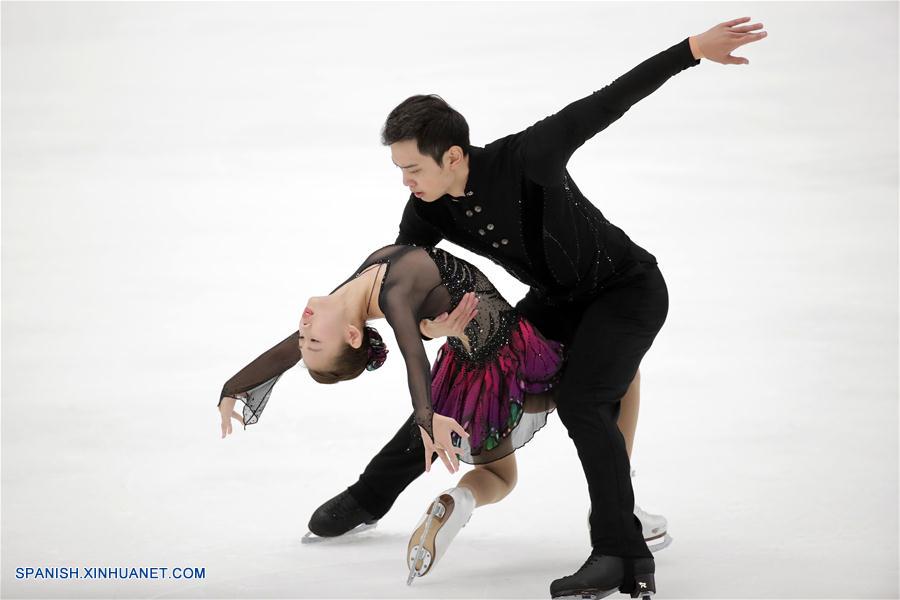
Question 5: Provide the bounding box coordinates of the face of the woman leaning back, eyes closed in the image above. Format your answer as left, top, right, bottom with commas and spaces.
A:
299, 296, 358, 371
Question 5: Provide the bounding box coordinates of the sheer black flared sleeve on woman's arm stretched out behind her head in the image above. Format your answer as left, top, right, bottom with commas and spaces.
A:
219, 331, 301, 429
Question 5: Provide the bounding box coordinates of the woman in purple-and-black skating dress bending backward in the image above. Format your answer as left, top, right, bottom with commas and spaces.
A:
219, 244, 563, 583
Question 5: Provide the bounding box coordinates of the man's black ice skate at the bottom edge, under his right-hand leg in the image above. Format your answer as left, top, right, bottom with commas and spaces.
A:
550, 552, 656, 600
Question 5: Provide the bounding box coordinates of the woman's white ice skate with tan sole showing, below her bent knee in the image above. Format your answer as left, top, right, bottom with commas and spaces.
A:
406, 487, 475, 585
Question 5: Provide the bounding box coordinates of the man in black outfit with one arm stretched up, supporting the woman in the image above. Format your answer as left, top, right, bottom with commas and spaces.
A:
310, 17, 766, 598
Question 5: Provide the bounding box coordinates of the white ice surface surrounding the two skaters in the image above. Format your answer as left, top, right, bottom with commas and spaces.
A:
2, 2, 898, 598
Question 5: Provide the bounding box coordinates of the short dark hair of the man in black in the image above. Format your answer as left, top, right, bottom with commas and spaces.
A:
381, 94, 469, 165
